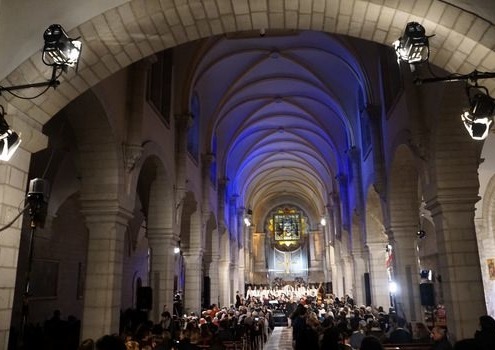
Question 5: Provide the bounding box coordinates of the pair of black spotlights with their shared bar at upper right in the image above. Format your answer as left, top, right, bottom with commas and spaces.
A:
393, 22, 495, 140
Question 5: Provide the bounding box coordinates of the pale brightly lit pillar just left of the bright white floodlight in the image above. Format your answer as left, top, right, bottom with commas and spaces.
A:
367, 242, 390, 310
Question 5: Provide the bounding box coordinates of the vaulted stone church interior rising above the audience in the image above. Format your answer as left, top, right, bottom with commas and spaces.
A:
0, 0, 495, 349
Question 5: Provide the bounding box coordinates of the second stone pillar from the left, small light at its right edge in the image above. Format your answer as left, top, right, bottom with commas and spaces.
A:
148, 232, 178, 323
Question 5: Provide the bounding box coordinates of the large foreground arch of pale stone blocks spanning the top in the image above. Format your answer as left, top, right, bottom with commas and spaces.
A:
2, 0, 494, 154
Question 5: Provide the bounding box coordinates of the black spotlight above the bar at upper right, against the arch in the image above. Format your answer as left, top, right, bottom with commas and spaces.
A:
393, 22, 430, 64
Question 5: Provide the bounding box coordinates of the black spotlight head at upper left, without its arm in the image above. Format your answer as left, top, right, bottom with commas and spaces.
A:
42, 24, 82, 70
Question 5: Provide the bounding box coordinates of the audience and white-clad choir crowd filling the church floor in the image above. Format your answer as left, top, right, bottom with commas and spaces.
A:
14, 289, 495, 350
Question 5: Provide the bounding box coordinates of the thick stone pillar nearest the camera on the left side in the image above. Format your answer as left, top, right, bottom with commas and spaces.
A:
81, 206, 132, 339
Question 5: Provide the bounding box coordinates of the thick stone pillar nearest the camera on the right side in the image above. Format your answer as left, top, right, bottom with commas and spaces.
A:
427, 196, 486, 339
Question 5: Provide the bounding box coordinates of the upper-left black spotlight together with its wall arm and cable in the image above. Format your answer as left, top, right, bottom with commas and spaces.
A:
0, 24, 82, 100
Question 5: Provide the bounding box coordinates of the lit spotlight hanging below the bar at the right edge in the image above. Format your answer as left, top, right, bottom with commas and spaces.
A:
461, 88, 495, 140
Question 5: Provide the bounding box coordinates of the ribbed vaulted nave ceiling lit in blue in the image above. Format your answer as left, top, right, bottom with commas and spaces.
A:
193, 32, 369, 221
